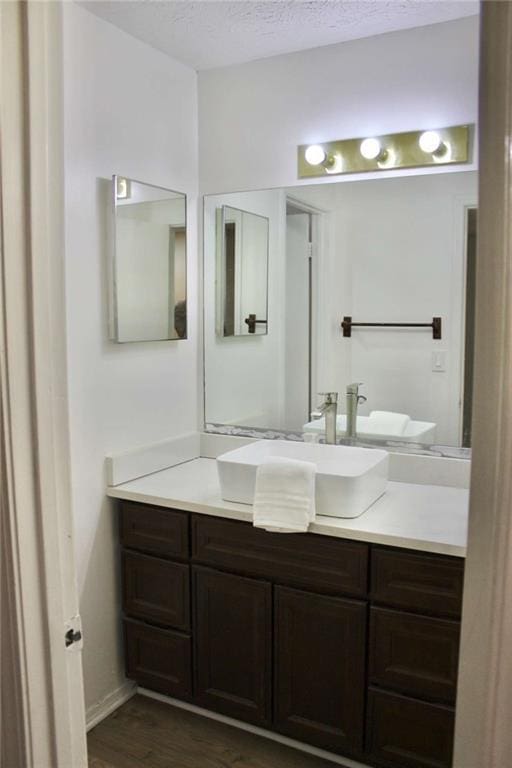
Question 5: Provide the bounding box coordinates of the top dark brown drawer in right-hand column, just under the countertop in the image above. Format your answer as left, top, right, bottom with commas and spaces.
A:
371, 547, 464, 617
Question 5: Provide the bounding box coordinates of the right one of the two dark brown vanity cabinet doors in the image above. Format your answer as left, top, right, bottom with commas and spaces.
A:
274, 587, 366, 752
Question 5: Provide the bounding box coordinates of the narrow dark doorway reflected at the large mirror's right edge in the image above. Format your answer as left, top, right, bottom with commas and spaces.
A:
462, 208, 477, 448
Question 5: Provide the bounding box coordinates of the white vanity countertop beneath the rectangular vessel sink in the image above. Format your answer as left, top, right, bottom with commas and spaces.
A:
107, 459, 469, 557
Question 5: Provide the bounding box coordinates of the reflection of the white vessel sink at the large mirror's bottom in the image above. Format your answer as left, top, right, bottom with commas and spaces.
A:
302, 412, 436, 443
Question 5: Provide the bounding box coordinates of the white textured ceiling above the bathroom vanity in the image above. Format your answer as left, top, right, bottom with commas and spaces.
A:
80, 0, 479, 69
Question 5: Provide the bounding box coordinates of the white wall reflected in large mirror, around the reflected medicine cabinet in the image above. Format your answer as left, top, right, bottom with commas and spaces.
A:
204, 190, 286, 428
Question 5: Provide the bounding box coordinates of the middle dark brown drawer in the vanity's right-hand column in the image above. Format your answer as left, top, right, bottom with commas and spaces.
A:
369, 608, 460, 703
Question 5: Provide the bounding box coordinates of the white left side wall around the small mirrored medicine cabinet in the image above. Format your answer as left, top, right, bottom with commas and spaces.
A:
64, 3, 200, 710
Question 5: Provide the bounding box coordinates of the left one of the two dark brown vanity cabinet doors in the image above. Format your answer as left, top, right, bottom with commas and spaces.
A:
193, 567, 272, 725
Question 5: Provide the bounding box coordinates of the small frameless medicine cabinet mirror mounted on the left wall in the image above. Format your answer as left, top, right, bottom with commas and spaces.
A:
110, 176, 187, 342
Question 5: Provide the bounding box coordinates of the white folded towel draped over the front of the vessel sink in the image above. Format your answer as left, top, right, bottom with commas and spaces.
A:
253, 456, 316, 533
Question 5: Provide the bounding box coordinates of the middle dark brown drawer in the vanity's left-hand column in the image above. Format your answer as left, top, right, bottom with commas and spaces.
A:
122, 551, 190, 631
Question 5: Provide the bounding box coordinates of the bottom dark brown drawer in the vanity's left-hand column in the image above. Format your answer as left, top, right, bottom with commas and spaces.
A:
124, 619, 192, 699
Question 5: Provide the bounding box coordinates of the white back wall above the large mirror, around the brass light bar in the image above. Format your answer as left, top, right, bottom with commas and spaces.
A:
199, 16, 478, 193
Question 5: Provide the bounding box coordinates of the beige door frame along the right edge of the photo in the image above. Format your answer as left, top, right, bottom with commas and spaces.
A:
454, 0, 512, 768
